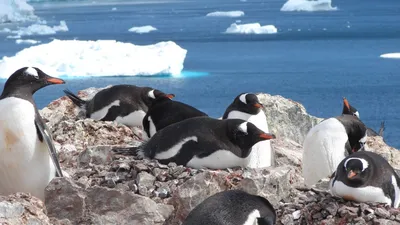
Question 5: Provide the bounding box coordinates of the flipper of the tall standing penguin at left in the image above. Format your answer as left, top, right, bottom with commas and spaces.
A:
35, 110, 63, 177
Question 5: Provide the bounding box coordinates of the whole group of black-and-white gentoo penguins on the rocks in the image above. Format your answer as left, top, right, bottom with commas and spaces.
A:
0, 67, 400, 225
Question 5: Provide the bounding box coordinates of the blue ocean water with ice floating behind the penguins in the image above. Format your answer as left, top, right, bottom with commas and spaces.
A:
0, 0, 400, 148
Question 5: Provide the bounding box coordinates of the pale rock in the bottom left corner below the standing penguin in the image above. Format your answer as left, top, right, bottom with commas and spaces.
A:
0, 193, 50, 225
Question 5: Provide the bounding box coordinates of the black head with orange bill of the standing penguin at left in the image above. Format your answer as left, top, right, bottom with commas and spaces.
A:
3, 67, 65, 95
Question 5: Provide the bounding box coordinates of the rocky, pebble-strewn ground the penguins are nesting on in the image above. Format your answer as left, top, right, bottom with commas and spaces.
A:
0, 89, 400, 225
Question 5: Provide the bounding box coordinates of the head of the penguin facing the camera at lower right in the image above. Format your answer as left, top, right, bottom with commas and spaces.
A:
343, 157, 370, 184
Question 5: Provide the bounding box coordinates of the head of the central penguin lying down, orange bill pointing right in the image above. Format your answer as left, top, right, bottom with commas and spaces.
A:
227, 119, 275, 155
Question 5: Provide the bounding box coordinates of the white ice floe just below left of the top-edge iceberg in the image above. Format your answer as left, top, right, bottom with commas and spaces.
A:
225, 23, 278, 34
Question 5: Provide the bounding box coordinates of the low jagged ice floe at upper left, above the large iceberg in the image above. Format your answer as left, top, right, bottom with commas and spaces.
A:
5, 20, 68, 38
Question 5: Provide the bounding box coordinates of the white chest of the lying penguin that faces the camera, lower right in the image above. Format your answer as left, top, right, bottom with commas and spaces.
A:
330, 181, 392, 205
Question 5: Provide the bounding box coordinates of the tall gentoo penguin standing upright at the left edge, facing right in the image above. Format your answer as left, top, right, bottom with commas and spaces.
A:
0, 67, 64, 200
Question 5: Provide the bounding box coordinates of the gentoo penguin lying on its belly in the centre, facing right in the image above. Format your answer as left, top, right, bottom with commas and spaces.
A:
114, 116, 275, 169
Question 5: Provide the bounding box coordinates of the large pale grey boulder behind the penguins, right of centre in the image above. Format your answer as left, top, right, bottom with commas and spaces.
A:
257, 93, 322, 144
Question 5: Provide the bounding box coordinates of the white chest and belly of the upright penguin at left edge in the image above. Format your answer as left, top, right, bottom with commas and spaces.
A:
0, 97, 55, 198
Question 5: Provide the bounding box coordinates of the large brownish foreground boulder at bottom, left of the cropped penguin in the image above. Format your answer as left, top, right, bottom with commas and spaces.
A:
45, 178, 174, 225
